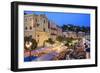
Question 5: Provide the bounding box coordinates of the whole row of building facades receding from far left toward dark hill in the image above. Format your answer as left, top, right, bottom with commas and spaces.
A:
24, 14, 84, 47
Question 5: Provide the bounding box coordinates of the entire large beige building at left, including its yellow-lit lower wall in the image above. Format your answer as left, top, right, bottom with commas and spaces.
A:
24, 14, 50, 47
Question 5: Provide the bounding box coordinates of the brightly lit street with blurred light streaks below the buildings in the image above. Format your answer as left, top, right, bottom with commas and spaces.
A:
25, 39, 89, 61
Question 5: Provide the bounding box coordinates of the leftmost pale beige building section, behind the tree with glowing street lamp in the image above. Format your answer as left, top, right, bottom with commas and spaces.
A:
24, 14, 36, 39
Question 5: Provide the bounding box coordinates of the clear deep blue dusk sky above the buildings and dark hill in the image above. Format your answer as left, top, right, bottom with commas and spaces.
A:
24, 11, 90, 26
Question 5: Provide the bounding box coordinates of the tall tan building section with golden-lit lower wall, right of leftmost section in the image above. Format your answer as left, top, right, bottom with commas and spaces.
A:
36, 14, 50, 47
